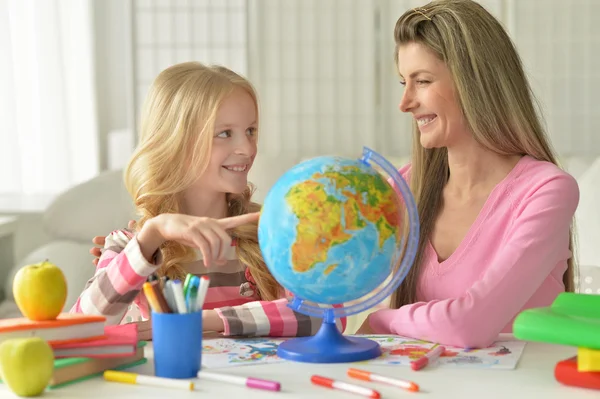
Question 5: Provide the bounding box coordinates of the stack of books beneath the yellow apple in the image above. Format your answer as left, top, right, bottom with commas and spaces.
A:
0, 313, 146, 389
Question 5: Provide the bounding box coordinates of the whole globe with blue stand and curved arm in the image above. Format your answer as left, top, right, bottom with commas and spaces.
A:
258, 148, 419, 362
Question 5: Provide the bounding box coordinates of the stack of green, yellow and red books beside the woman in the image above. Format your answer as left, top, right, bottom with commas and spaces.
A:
513, 292, 600, 389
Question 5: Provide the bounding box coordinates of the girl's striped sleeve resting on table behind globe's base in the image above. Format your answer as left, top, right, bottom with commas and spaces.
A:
215, 298, 346, 337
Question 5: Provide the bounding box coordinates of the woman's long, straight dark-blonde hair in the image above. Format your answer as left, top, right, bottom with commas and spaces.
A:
391, 0, 574, 308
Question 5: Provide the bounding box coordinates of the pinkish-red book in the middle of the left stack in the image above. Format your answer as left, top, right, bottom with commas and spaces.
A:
52, 324, 138, 359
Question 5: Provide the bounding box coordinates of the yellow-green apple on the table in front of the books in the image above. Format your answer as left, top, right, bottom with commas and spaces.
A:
0, 337, 54, 396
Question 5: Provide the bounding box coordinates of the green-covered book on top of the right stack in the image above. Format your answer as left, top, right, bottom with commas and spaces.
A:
513, 292, 600, 349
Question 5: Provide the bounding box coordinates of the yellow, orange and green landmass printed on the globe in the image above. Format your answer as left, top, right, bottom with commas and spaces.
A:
285, 165, 400, 274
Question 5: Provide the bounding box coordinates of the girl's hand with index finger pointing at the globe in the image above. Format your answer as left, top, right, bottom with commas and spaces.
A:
138, 212, 260, 267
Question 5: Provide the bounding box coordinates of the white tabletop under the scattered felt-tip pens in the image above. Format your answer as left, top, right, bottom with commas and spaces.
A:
0, 342, 600, 399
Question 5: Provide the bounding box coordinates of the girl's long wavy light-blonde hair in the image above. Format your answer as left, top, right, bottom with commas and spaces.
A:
125, 62, 281, 300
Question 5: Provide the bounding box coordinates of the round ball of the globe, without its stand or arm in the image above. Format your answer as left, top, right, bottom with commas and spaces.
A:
258, 157, 402, 304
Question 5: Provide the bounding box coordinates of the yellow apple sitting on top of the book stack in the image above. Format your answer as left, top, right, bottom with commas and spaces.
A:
13, 260, 67, 321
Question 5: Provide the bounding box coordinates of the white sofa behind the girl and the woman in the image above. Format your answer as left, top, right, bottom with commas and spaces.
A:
0, 154, 600, 329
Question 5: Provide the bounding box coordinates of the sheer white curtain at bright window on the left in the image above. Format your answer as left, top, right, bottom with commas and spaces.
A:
0, 0, 99, 195
